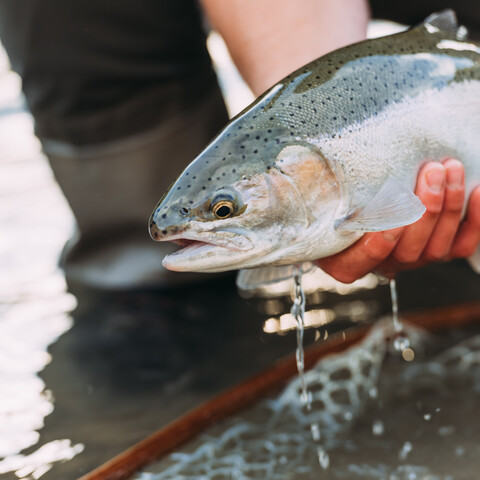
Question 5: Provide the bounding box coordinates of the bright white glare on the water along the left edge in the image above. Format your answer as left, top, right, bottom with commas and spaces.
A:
0, 51, 83, 479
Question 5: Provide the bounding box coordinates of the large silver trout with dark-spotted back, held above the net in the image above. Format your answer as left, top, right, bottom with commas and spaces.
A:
149, 10, 480, 282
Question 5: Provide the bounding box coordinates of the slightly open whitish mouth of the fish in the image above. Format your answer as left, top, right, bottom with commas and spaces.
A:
157, 231, 254, 272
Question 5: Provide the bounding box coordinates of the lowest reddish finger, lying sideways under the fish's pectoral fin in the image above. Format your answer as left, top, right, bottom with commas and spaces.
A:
317, 227, 404, 283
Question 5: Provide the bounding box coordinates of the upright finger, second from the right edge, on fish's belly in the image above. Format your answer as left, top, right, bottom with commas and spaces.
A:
423, 159, 465, 261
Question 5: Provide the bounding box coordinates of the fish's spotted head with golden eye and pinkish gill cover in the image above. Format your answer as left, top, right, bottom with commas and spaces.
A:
150, 114, 338, 272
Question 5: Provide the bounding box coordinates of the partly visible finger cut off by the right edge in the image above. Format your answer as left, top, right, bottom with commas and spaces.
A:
450, 187, 480, 258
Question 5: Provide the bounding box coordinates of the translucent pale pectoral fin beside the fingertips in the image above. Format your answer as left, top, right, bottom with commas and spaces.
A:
335, 178, 425, 232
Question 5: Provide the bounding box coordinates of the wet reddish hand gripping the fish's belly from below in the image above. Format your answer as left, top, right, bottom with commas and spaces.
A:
316, 159, 480, 283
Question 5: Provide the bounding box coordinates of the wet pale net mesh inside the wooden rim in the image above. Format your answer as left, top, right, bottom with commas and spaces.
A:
137, 321, 480, 480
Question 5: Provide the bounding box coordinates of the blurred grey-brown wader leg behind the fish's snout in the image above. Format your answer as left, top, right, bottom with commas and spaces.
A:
42, 89, 227, 289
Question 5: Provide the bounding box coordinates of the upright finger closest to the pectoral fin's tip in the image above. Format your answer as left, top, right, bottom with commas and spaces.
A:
393, 162, 446, 263
